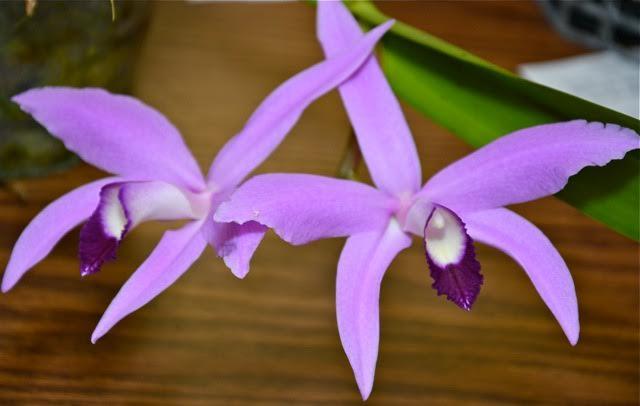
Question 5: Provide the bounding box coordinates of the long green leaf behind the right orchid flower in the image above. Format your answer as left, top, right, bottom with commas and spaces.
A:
347, 1, 640, 240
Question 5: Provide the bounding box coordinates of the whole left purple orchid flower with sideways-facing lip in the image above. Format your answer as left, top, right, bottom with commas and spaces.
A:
2, 21, 393, 342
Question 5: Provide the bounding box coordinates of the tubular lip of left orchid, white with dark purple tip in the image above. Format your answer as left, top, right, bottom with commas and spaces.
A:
79, 181, 197, 276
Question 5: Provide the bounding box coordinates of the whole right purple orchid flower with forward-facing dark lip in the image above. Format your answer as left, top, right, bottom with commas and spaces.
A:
214, 2, 640, 399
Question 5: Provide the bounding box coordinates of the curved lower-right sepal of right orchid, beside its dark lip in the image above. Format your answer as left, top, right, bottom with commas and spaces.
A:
463, 209, 580, 345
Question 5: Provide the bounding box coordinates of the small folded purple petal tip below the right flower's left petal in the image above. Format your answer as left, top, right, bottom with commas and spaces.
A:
202, 216, 267, 279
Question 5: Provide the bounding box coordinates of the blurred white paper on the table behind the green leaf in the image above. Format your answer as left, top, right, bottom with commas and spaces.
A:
518, 49, 640, 118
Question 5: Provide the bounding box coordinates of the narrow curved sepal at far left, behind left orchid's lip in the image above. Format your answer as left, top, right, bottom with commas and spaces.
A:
2, 178, 118, 292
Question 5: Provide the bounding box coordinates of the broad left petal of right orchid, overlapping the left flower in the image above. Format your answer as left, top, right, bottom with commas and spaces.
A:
214, 174, 396, 244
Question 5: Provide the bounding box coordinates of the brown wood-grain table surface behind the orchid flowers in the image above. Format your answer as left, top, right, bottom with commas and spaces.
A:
0, 1, 639, 405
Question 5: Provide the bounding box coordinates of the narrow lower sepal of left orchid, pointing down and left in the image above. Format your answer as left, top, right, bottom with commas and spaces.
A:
91, 221, 207, 343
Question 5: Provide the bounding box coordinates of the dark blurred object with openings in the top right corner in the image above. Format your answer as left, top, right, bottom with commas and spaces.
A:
539, 0, 640, 57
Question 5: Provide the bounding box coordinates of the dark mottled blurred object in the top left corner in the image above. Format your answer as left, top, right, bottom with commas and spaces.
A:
0, 0, 150, 181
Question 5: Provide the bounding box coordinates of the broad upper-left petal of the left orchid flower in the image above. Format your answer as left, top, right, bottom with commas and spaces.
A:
12, 87, 204, 190
